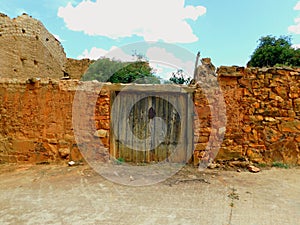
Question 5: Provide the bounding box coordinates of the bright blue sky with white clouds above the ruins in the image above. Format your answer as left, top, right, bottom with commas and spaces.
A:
0, 0, 300, 76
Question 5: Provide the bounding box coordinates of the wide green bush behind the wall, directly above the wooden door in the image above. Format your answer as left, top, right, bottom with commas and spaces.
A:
83, 58, 160, 84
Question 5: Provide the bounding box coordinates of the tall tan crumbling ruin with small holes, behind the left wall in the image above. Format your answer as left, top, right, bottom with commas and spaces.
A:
0, 13, 66, 78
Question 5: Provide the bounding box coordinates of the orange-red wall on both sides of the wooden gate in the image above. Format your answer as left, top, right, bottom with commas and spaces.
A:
0, 67, 300, 164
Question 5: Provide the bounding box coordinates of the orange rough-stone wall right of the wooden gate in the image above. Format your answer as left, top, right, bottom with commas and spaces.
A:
194, 67, 300, 165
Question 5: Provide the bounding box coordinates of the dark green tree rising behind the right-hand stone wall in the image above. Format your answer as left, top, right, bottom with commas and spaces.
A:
247, 35, 300, 67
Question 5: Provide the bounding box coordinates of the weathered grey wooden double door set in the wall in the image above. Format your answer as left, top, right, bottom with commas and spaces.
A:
110, 92, 193, 163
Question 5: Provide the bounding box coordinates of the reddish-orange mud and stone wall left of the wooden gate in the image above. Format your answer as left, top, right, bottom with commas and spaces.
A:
0, 78, 109, 163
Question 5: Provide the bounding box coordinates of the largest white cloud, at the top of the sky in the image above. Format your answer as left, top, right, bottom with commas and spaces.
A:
57, 0, 206, 43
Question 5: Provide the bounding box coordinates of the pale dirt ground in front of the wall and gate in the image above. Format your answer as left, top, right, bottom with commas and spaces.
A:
0, 165, 300, 225
